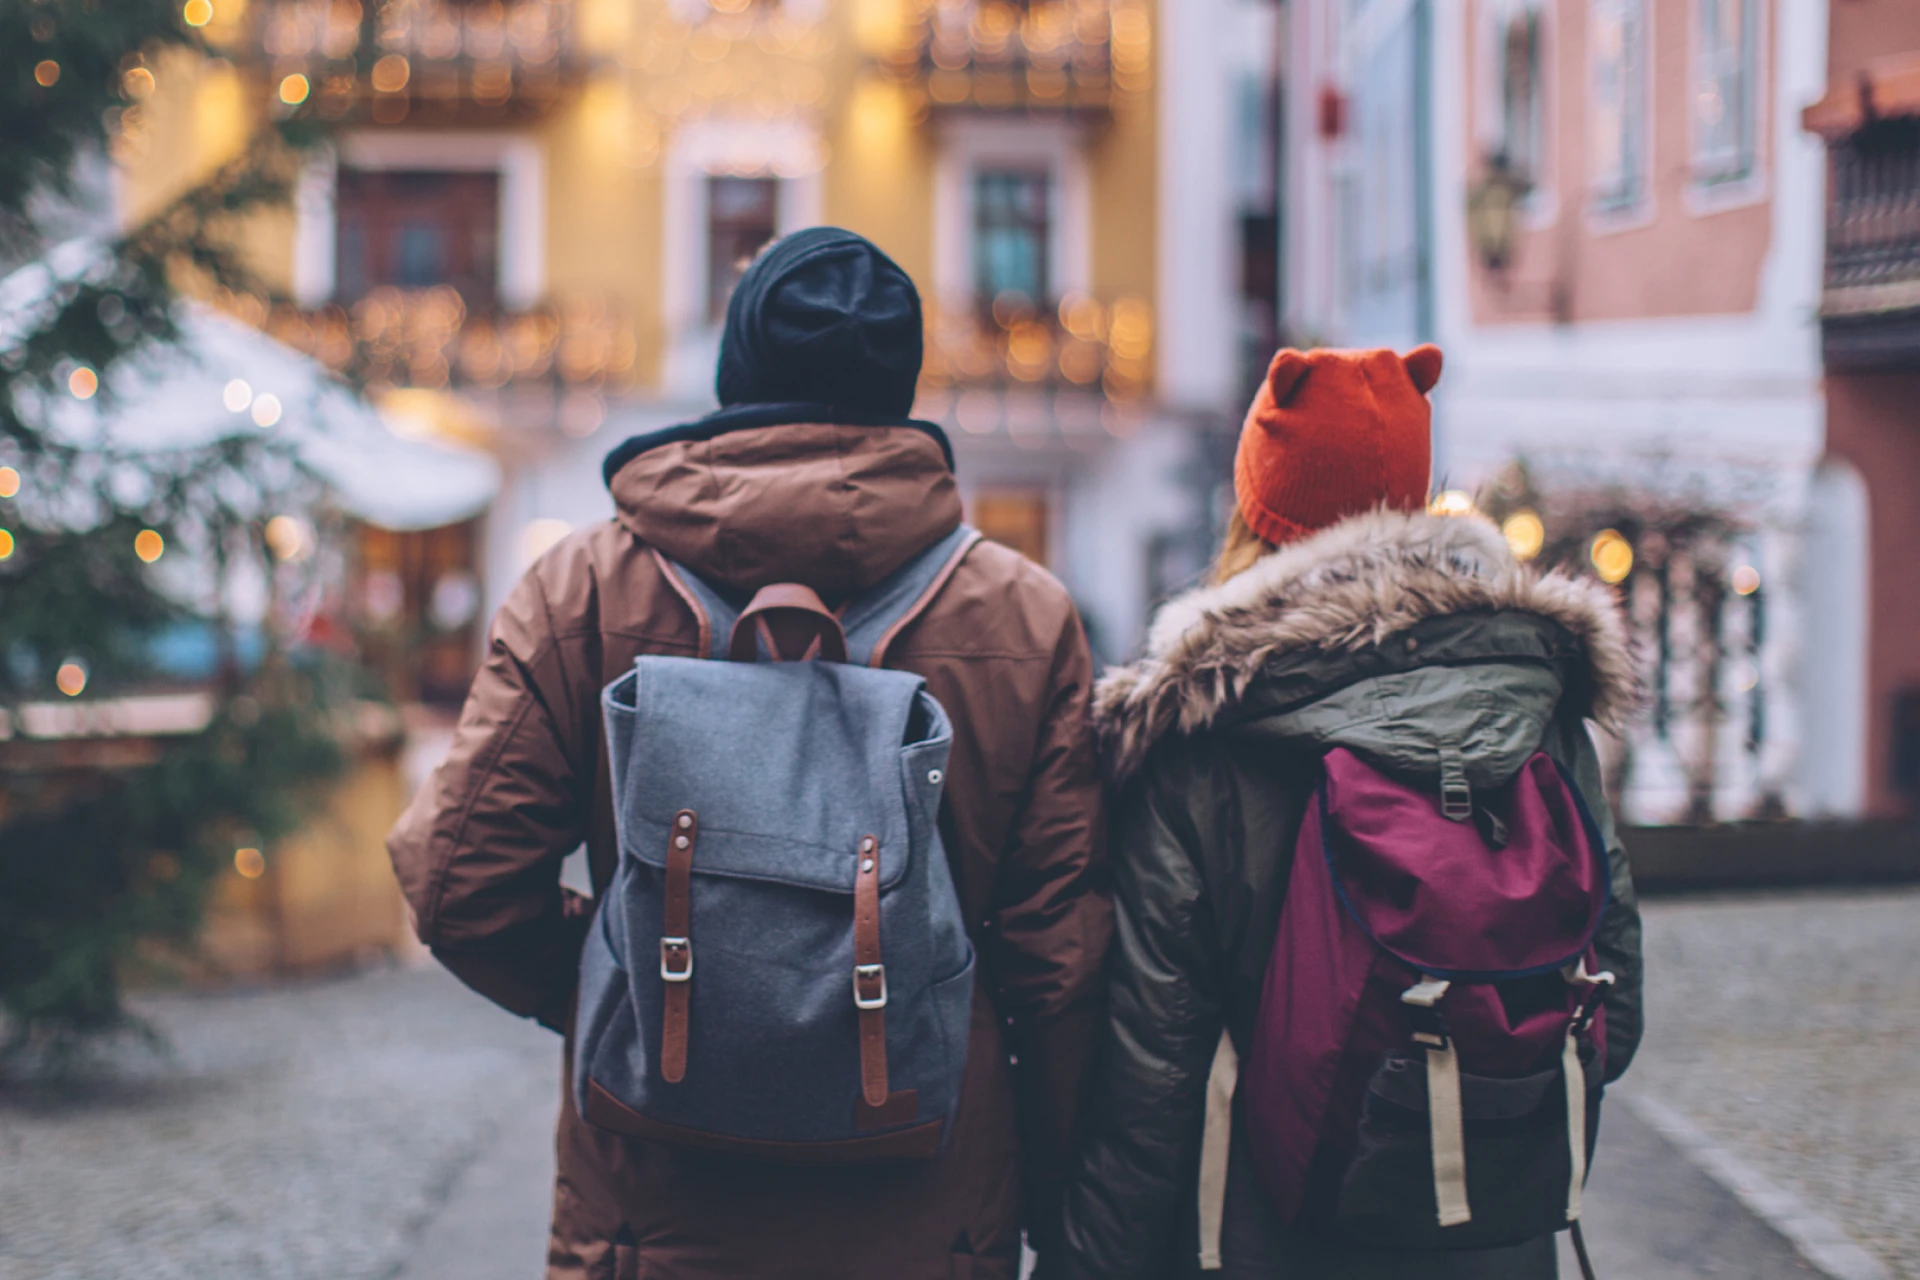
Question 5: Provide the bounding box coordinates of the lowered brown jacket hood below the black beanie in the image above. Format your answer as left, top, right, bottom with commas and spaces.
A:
609, 422, 960, 601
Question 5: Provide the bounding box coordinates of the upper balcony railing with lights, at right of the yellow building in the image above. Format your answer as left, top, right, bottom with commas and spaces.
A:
887, 0, 1152, 115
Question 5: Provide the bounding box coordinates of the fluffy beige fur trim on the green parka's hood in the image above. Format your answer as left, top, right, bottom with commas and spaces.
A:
1094, 510, 1636, 781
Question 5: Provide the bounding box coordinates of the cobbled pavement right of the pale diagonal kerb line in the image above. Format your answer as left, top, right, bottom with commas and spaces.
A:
1626, 889, 1920, 1280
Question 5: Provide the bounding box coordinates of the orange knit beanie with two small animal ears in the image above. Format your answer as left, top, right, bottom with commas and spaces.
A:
1233, 345, 1440, 547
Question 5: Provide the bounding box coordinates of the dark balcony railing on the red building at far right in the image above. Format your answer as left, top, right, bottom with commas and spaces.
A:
1820, 119, 1920, 368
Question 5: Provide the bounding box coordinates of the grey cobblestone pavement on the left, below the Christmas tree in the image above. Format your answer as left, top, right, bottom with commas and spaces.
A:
0, 969, 559, 1280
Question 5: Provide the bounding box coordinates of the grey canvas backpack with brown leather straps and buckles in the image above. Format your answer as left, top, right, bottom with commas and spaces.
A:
572, 526, 979, 1165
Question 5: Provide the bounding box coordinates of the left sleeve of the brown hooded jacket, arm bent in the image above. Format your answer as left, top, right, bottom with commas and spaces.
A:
388, 566, 595, 1031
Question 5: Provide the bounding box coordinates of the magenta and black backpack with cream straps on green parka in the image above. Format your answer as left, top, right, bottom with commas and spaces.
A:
1240, 748, 1613, 1249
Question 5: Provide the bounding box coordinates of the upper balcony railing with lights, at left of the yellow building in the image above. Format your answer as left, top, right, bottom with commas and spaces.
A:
240, 0, 584, 123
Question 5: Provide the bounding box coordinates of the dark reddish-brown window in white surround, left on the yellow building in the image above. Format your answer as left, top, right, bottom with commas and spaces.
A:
334, 169, 499, 309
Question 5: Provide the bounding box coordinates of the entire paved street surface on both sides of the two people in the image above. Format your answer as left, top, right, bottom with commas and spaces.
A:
0, 890, 1920, 1280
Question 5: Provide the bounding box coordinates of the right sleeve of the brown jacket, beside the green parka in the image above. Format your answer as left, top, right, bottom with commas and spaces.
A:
985, 614, 1114, 1261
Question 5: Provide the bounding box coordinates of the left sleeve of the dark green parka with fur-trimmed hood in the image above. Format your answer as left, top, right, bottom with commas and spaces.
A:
1066, 762, 1225, 1280
